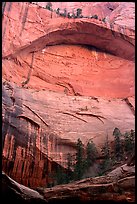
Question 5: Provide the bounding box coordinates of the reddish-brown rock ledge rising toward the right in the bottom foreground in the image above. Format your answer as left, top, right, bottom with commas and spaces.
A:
38, 165, 135, 202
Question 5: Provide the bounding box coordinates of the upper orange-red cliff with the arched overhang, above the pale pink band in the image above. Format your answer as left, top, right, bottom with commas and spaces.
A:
3, 3, 135, 98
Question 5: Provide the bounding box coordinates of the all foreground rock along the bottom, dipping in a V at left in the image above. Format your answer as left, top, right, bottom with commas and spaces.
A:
2, 164, 135, 204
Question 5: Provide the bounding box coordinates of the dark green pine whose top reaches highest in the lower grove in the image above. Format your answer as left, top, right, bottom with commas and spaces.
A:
113, 128, 123, 161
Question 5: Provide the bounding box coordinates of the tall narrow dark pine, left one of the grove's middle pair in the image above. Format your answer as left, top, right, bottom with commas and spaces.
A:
74, 139, 85, 180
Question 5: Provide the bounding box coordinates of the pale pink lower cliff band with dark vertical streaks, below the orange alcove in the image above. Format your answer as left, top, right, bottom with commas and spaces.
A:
2, 79, 135, 187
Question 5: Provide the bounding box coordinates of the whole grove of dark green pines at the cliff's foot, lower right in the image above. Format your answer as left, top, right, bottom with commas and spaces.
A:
48, 127, 135, 186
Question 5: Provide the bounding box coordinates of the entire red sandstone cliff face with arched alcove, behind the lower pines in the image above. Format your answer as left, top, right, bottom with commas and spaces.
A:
2, 2, 135, 188
